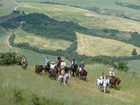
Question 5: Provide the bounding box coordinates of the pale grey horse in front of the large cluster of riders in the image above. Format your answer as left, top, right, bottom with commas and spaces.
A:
58, 73, 70, 86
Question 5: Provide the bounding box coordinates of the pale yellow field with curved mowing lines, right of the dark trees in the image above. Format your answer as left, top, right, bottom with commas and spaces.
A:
77, 33, 140, 56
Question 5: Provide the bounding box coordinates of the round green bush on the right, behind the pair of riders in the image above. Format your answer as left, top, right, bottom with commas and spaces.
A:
114, 60, 129, 72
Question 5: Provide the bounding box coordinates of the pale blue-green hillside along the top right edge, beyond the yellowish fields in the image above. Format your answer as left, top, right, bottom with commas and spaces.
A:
17, 0, 140, 21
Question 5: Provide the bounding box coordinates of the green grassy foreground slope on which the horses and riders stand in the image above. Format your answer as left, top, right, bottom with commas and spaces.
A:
0, 64, 140, 105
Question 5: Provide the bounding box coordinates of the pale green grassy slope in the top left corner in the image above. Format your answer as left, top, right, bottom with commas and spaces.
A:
0, 0, 17, 16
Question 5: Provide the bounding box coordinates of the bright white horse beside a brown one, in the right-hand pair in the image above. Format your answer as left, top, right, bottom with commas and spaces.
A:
96, 79, 109, 93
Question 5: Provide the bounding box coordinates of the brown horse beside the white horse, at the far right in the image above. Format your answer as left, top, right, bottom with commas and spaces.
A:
107, 76, 121, 87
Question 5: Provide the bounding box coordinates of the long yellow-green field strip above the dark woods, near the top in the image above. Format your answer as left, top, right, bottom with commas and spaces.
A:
20, 3, 140, 32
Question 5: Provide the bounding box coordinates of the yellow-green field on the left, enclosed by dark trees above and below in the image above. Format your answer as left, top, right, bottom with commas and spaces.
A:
14, 29, 72, 50
